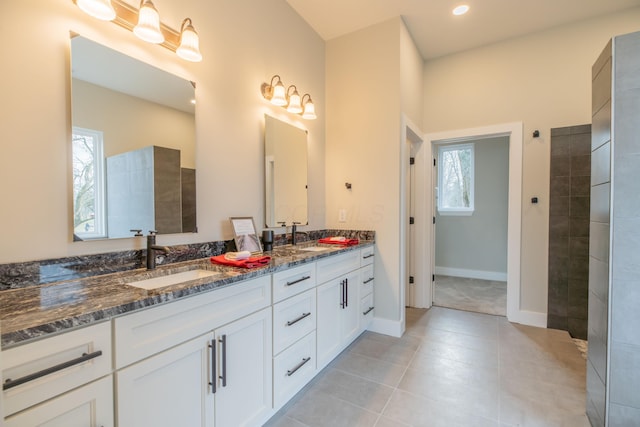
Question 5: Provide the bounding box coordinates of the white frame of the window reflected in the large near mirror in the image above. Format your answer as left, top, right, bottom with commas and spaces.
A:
71, 126, 107, 240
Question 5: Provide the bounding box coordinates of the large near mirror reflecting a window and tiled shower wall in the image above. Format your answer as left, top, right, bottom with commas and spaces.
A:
71, 35, 197, 241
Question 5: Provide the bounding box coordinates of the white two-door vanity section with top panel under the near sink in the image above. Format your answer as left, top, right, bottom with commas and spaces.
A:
114, 276, 272, 427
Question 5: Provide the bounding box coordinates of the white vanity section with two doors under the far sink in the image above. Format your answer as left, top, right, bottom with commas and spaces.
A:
316, 251, 360, 369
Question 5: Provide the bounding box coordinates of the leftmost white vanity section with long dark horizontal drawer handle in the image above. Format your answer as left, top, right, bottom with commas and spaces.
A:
2, 322, 113, 426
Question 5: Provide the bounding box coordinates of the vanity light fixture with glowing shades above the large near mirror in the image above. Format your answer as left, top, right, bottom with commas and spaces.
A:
73, 0, 202, 62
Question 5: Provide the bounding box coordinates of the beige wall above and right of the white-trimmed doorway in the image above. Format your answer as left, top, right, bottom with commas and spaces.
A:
423, 8, 640, 315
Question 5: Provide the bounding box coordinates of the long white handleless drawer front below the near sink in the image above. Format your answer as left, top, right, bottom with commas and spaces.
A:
114, 275, 271, 368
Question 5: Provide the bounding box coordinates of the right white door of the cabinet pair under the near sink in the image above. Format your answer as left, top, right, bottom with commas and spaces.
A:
214, 308, 273, 427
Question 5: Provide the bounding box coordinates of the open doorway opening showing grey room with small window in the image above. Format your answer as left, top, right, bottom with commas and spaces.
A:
432, 135, 509, 316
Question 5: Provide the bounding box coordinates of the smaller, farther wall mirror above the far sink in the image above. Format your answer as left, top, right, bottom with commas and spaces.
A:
264, 115, 308, 227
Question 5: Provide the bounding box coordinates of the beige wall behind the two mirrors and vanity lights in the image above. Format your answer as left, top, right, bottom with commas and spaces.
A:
0, 0, 325, 263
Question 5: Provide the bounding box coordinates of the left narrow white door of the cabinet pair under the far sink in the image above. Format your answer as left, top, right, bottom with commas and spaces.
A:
316, 279, 343, 370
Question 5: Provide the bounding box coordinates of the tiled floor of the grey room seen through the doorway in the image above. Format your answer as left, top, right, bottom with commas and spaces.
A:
433, 275, 507, 316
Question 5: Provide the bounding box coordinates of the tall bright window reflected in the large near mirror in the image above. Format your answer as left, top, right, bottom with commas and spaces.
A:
71, 127, 107, 239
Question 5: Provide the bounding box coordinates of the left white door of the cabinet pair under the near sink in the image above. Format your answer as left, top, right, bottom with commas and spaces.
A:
116, 333, 214, 427
